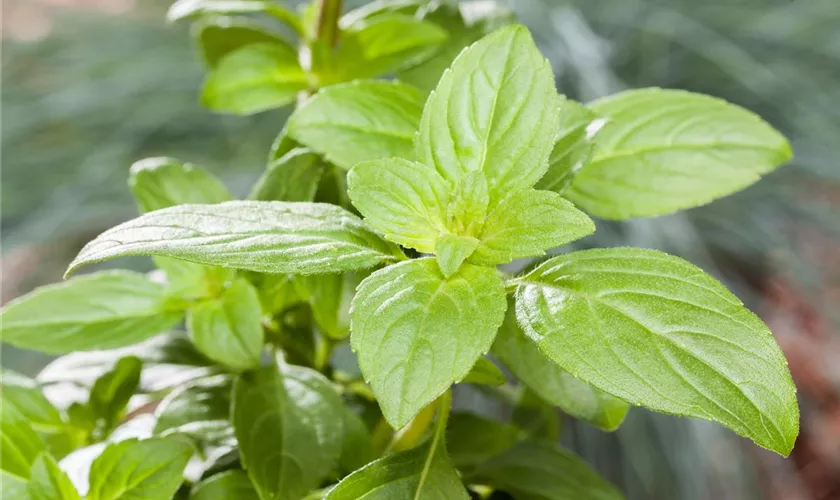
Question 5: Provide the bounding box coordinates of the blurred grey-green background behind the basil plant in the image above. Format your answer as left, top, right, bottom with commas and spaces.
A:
0, 0, 840, 500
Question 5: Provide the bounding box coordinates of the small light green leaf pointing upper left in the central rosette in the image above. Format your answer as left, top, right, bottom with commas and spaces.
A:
347, 158, 449, 253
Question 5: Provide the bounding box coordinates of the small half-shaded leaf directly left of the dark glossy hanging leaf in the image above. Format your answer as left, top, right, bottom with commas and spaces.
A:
154, 375, 233, 434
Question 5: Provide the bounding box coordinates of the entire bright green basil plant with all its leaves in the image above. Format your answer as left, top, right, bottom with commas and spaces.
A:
0, 0, 799, 500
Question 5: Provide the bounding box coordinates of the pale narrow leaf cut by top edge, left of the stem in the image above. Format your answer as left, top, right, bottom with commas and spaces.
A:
166, 0, 303, 33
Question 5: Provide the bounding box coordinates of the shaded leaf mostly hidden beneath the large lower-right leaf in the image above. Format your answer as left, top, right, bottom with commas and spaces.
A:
493, 307, 630, 431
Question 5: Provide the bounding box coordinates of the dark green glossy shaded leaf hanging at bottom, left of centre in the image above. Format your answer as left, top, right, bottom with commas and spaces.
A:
232, 362, 343, 500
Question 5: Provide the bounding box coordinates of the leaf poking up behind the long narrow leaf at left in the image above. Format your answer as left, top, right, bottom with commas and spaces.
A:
128, 158, 231, 213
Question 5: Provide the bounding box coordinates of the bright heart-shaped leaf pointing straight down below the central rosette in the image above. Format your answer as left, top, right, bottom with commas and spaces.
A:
350, 258, 507, 428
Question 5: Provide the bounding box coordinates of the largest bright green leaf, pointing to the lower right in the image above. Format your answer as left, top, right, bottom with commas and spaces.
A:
516, 248, 799, 455
